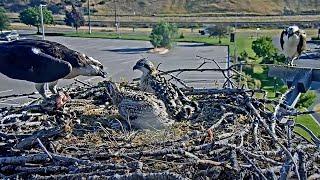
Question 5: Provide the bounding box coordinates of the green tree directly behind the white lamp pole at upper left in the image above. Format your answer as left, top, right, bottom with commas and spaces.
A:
19, 7, 54, 33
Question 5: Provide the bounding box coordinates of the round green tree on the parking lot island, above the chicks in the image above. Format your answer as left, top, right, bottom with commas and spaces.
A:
150, 21, 178, 49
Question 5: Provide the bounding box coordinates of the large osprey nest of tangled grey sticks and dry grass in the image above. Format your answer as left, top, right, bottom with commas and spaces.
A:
0, 82, 320, 179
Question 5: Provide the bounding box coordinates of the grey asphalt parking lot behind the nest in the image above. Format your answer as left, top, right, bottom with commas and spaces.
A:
0, 37, 227, 107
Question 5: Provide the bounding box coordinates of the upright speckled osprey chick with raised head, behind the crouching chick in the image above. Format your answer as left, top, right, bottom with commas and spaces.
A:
133, 58, 198, 120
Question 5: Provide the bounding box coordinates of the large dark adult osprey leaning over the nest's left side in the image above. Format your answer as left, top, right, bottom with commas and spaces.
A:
0, 39, 105, 107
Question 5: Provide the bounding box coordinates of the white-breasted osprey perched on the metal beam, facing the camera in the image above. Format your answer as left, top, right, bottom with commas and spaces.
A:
280, 26, 307, 66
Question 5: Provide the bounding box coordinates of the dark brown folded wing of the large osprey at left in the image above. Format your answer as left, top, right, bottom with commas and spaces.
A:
0, 45, 72, 83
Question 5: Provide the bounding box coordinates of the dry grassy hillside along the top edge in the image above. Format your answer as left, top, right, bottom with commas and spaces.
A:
0, 0, 320, 15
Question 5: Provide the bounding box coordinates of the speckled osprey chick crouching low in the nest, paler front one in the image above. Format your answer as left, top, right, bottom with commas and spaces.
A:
106, 82, 173, 129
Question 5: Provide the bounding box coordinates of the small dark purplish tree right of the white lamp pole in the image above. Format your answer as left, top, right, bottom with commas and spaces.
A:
64, 5, 84, 32
